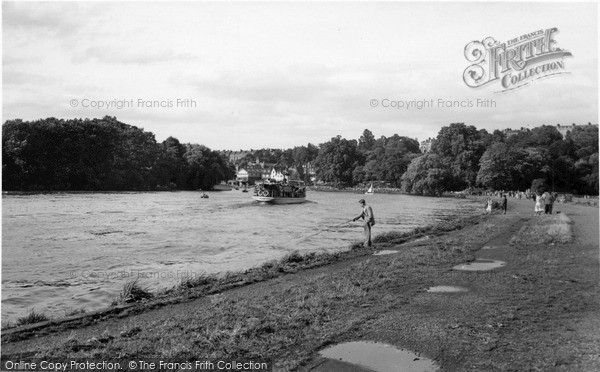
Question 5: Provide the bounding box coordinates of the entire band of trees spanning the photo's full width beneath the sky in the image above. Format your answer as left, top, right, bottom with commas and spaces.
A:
2, 116, 598, 195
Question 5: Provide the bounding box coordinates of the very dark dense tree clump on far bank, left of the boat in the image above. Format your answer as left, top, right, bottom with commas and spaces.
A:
2, 116, 234, 191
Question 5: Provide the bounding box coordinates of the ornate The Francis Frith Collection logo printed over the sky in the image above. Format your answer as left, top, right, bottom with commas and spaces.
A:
463, 27, 571, 92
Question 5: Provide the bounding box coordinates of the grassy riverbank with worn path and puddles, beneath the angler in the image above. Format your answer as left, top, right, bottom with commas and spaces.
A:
2, 200, 600, 371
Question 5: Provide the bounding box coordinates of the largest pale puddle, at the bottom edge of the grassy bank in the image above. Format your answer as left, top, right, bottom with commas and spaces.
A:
320, 341, 439, 372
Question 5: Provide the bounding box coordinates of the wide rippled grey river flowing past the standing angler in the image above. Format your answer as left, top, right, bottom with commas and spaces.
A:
2, 191, 479, 323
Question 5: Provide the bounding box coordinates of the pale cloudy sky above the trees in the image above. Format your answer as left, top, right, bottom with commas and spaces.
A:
2, 2, 598, 150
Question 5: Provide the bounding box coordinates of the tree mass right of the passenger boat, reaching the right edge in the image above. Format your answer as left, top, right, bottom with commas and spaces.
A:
315, 123, 598, 195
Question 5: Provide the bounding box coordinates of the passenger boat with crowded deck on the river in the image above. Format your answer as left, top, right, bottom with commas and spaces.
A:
252, 180, 306, 204
